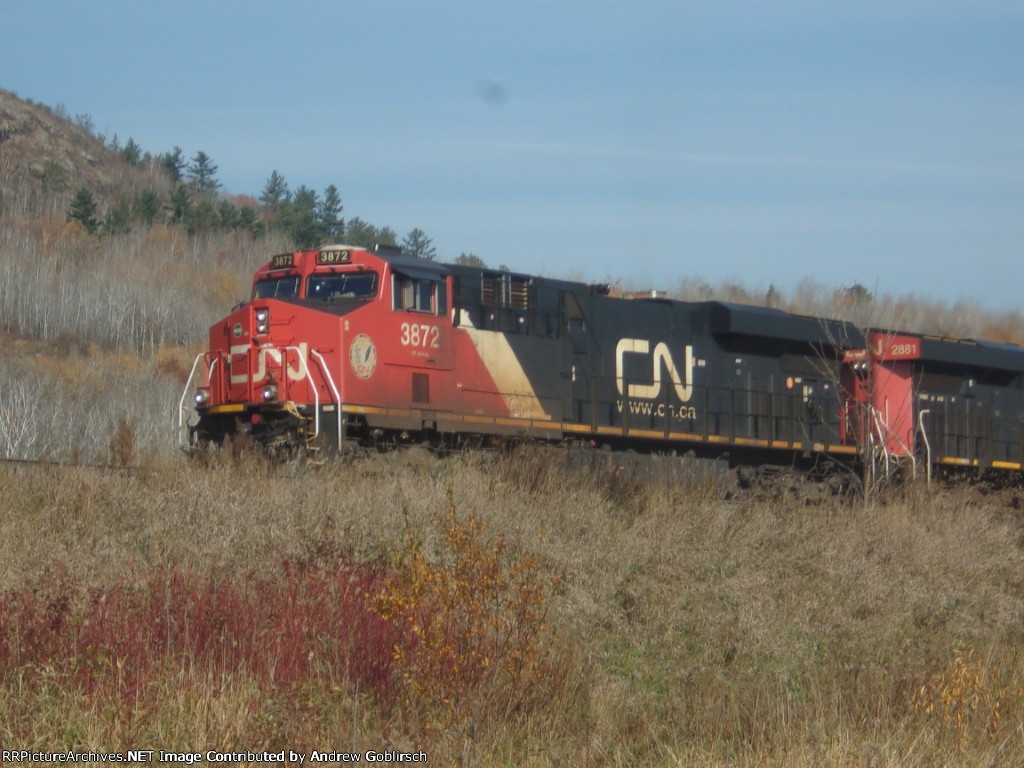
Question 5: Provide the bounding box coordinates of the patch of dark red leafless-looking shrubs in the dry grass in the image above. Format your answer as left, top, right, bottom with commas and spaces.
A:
0, 559, 396, 702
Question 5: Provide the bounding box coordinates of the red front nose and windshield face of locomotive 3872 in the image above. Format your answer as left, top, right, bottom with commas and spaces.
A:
179, 246, 395, 451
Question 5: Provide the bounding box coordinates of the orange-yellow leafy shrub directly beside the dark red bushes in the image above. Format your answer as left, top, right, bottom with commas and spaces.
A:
371, 492, 551, 727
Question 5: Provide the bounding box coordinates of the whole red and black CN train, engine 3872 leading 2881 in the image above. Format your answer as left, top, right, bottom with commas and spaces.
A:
178, 245, 1024, 473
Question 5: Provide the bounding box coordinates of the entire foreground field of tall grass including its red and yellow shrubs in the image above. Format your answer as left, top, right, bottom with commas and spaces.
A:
0, 446, 1024, 767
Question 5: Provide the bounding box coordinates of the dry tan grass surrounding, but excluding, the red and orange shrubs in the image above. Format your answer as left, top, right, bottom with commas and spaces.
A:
0, 451, 1024, 766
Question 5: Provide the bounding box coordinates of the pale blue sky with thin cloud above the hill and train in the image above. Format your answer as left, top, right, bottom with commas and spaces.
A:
0, 0, 1024, 308
